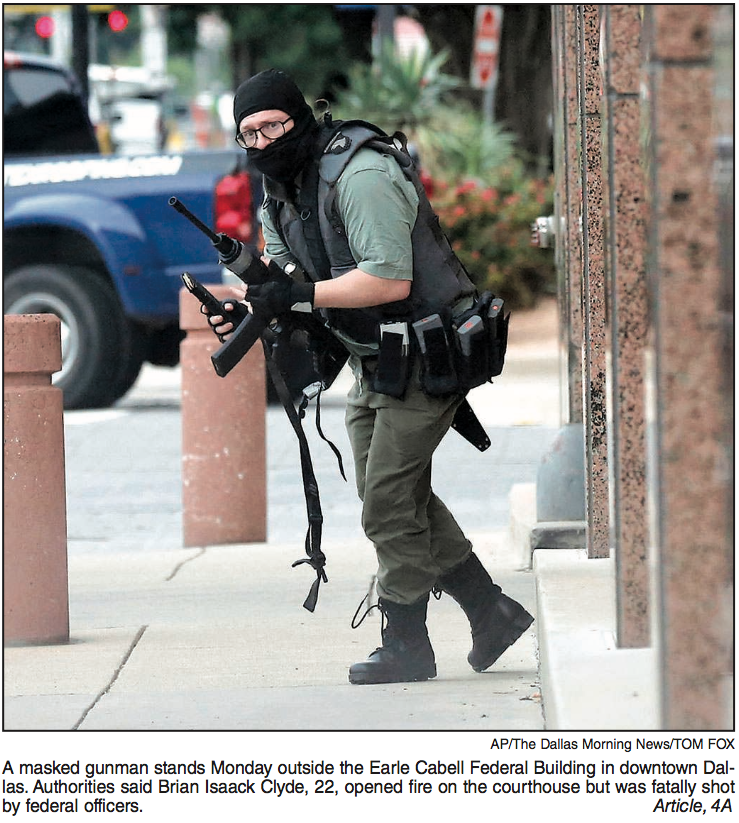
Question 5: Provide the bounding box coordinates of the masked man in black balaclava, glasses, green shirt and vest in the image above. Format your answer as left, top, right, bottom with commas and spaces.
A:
209, 69, 533, 684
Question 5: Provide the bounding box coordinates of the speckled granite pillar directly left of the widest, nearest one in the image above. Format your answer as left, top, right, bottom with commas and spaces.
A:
601, 5, 649, 648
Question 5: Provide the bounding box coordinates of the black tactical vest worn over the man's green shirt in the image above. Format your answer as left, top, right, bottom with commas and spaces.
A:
265, 121, 475, 343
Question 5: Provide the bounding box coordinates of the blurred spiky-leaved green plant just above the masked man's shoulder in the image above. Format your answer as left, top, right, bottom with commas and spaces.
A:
334, 39, 460, 138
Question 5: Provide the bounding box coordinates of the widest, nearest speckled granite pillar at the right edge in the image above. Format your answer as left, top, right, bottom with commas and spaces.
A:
642, 5, 733, 730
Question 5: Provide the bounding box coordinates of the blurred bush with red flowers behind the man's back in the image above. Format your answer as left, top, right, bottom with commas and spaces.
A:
431, 170, 555, 308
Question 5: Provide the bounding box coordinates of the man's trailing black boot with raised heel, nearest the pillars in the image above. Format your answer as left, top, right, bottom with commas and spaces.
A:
437, 552, 534, 672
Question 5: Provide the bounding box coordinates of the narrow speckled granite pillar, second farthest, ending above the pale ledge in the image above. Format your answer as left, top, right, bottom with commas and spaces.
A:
576, 5, 610, 557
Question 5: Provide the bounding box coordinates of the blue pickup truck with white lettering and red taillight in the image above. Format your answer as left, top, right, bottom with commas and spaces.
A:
3, 53, 261, 409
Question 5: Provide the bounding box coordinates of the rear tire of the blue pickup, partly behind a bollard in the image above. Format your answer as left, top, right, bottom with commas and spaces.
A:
4, 265, 143, 409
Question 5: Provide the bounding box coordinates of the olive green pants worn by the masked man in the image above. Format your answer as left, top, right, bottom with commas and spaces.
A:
346, 366, 472, 605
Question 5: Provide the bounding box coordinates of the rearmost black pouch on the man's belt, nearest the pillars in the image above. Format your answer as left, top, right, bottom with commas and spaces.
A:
453, 291, 510, 391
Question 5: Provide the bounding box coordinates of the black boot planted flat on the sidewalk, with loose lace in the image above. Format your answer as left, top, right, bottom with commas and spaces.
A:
349, 595, 436, 684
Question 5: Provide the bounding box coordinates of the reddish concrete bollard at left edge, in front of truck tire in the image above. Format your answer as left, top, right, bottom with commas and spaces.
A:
3, 314, 69, 644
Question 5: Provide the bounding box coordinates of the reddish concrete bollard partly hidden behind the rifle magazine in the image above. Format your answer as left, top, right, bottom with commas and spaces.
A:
180, 286, 267, 547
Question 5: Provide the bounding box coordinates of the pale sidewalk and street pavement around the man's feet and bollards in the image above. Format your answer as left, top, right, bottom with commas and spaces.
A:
4, 302, 559, 731
